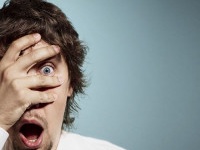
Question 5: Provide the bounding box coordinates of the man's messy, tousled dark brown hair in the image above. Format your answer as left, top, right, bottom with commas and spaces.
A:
0, 0, 87, 126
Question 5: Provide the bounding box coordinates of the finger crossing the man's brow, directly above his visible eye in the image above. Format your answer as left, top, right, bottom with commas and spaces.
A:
16, 45, 60, 70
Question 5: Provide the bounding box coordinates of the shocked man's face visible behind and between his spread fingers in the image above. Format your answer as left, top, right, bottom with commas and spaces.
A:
6, 41, 72, 150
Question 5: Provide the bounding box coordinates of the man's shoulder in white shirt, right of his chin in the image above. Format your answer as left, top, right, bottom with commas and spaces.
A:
58, 131, 124, 150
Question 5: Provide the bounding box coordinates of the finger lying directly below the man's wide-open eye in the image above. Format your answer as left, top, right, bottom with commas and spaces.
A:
16, 75, 63, 90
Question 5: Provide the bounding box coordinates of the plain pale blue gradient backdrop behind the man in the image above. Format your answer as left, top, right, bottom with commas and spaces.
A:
1, 0, 200, 150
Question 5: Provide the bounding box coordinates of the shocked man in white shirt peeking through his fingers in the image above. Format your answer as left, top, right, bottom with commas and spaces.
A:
0, 0, 125, 150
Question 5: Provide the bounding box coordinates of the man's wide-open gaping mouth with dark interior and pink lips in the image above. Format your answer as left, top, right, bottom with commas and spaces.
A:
19, 123, 43, 149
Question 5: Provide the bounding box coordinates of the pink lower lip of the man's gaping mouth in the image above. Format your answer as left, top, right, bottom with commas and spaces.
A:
20, 132, 43, 149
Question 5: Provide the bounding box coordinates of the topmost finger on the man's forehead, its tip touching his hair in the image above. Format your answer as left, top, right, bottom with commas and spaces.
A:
2, 33, 41, 62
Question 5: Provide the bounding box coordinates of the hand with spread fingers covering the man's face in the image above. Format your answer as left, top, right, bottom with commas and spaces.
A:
0, 34, 61, 130
